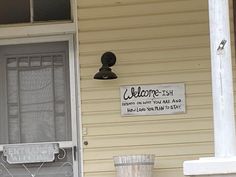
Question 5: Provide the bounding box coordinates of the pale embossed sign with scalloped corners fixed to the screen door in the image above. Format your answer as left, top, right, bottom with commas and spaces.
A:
3, 143, 59, 164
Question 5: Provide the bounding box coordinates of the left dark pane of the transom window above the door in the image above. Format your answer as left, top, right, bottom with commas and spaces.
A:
0, 0, 30, 24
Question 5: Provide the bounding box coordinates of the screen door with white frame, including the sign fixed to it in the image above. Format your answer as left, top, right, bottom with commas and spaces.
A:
0, 42, 78, 177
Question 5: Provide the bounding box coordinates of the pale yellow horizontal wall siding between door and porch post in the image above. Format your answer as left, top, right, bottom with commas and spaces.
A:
78, 0, 235, 177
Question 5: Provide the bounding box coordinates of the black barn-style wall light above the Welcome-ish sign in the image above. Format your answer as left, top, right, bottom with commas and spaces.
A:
93, 52, 117, 80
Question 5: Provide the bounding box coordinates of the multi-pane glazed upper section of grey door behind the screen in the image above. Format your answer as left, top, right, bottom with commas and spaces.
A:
7, 53, 71, 143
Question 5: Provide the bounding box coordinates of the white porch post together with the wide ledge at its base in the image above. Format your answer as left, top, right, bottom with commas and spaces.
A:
183, 0, 236, 176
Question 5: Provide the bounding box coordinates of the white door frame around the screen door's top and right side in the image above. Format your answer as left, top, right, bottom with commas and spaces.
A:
0, 34, 83, 177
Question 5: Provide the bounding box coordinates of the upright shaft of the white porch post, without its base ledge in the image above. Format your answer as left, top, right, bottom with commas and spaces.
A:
208, 0, 236, 157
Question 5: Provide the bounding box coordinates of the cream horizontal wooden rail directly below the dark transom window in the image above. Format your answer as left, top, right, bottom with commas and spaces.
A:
0, 22, 76, 39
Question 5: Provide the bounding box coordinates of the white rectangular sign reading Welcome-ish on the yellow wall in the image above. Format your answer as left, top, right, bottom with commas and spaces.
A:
120, 83, 185, 116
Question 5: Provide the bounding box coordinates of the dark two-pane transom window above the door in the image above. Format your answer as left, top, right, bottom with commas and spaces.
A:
0, 0, 71, 24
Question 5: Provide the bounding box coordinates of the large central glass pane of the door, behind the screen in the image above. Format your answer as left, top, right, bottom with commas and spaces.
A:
19, 68, 56, 143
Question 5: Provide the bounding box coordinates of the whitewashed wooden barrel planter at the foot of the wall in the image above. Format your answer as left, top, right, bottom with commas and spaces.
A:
113, 154, 155, 177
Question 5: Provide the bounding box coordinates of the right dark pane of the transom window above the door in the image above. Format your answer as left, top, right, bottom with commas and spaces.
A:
34, 0, 71, 21
